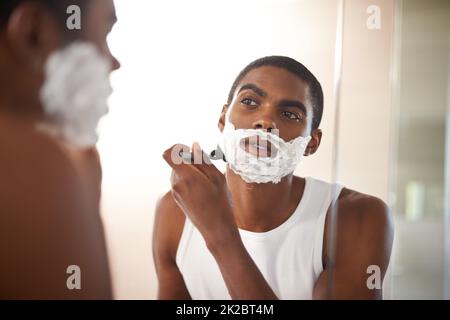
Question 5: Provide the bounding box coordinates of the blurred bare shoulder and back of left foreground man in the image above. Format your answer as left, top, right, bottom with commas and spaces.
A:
0, 120, 111, 299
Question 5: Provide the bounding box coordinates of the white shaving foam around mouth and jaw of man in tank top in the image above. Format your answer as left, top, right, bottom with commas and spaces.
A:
221, 110, 311, 183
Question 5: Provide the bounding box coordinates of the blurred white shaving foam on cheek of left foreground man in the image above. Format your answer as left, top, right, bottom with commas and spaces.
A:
39, 42, 112, 148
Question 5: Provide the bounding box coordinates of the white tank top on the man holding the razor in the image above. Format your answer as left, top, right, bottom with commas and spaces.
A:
176, 177, 342, 300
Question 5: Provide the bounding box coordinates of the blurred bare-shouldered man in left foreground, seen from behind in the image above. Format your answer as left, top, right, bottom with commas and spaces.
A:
0, 0, 119, 299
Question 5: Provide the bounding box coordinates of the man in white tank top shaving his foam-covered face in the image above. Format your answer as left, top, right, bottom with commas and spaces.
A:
153, 56, 393, 299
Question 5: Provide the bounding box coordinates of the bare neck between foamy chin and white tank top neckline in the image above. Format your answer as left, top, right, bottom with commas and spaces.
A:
227, 168, 305, 232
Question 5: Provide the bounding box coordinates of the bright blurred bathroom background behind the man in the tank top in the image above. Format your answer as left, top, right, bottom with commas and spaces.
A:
99, 0, 450, 299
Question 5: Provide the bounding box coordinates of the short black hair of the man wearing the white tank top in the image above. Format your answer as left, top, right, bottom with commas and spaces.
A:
227, 56, 323, 130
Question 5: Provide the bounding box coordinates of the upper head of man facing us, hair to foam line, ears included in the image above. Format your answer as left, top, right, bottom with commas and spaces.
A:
219, 56, 323, 155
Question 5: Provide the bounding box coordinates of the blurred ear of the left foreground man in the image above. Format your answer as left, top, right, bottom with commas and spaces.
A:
6, 1, 61, 70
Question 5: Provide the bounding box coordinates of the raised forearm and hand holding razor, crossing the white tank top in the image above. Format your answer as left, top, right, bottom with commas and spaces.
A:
163, 144, 277, 299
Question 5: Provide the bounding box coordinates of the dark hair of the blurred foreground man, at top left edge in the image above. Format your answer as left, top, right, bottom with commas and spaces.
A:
0, 0, 89, 29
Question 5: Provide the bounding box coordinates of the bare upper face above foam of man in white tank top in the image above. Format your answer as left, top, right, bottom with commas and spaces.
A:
224, 66, 312, 141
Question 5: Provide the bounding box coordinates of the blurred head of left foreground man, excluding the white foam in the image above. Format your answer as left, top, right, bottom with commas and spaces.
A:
0, 0, 119, 114
